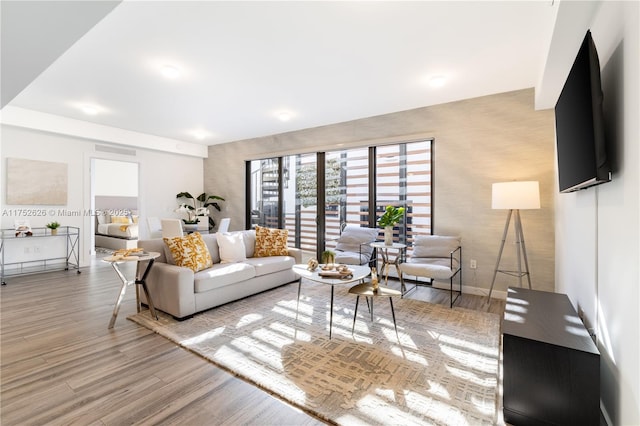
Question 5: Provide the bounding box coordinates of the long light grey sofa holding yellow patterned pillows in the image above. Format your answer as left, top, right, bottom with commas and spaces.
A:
138, 230, 302, 319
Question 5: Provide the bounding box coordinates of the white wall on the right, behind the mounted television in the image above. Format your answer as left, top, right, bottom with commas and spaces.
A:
555, 2, 640, 425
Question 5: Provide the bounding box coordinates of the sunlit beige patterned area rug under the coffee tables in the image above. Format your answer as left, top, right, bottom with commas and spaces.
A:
129, 280, 500, 425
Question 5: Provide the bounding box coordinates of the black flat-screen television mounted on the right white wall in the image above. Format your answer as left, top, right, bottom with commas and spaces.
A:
555, 31, 611, 192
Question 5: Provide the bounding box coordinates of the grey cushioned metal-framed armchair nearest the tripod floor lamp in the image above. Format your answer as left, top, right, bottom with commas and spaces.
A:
398, 235, 462, 307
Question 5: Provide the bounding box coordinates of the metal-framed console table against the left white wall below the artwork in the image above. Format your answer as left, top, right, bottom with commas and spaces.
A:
0, 226, 80, 285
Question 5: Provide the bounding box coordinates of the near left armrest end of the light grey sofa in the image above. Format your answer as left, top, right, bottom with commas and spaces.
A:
140, 262, 196, 318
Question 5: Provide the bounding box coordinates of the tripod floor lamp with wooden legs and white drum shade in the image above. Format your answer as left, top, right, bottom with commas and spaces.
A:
488, 181, 540, 300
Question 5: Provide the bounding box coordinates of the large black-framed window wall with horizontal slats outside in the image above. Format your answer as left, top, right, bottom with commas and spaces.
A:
247, 140, 432, 257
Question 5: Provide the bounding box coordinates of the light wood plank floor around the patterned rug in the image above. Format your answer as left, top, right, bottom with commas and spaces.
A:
0, 261, 504, 426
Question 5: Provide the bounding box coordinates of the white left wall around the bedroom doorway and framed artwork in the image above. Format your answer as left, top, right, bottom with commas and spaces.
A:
0, 125, 204, 266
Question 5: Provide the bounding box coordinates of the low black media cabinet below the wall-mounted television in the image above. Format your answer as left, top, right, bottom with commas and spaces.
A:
502, 287, 600, 426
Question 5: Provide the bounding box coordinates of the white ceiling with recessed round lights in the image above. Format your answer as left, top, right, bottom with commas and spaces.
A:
2, 1, 557, 145
